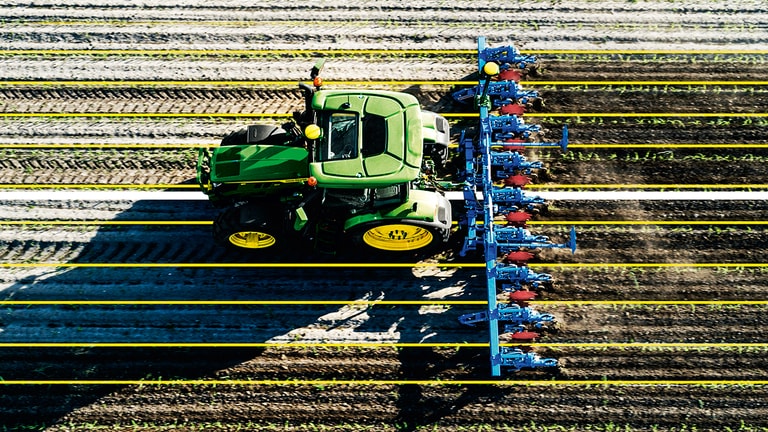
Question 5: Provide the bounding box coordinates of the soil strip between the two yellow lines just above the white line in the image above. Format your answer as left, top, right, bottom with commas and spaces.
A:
0, 147, 768, 187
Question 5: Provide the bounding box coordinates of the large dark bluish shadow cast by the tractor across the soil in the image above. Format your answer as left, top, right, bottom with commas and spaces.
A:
0, 201, 487, 430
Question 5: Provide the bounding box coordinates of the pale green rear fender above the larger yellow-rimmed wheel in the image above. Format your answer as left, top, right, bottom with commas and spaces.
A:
344, 189, 452, 235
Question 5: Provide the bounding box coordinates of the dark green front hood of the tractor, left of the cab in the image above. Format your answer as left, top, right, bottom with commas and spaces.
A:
211, 144, 308, 183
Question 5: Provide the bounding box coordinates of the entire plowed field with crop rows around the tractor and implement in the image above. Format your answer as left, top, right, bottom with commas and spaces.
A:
0, 0, 768, 431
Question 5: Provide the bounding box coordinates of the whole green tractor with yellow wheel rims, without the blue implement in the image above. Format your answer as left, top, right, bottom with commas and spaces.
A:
197, 61, 452, 257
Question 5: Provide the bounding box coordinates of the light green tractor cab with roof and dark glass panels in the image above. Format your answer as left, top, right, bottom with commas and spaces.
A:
309, 90, 424, 189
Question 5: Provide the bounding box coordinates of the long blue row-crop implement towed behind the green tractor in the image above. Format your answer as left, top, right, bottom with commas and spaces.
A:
454, 37, 576, 376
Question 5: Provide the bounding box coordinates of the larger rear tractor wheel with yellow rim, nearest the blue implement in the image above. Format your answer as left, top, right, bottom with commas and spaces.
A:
347, 219, 450, 257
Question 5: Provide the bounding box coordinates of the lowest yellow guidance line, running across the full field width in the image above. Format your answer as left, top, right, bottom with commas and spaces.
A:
0, 379, 768, 387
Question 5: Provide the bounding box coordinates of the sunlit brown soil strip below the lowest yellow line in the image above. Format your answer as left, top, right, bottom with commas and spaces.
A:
11, 386, 765, 430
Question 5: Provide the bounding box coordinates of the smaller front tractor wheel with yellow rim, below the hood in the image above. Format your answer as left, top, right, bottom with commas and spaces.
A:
213, 203, 292, 259
